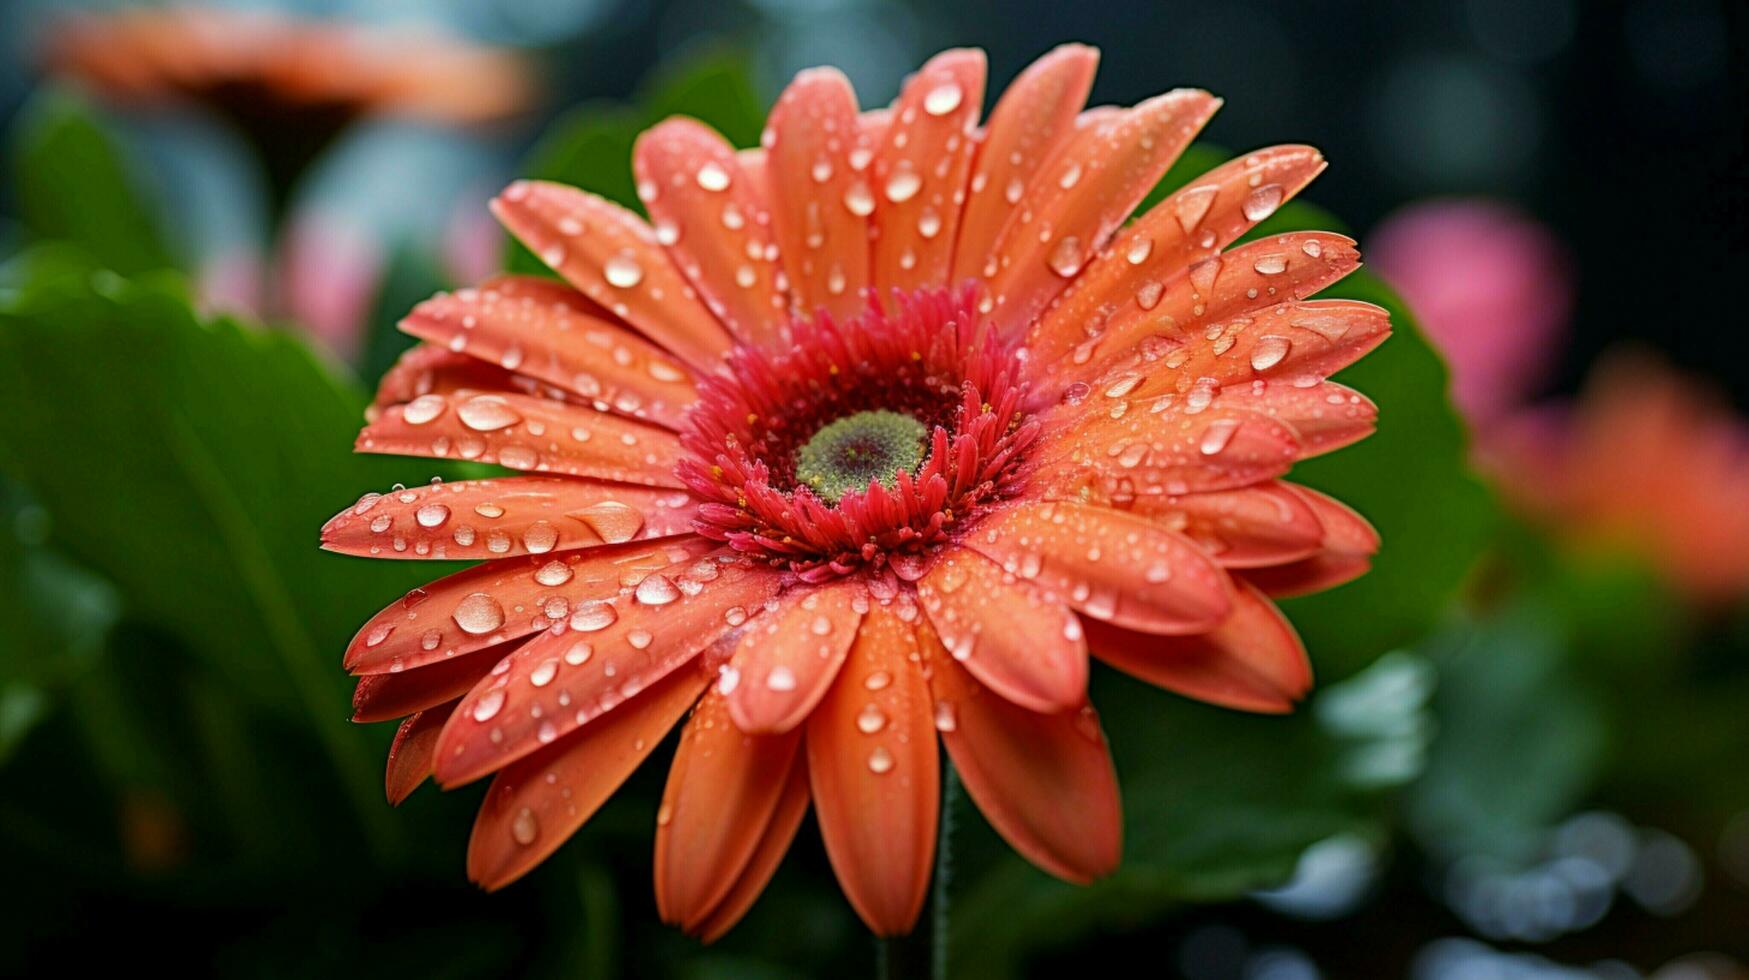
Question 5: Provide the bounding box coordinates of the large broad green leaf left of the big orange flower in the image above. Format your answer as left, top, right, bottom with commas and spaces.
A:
0, 253, 465, 857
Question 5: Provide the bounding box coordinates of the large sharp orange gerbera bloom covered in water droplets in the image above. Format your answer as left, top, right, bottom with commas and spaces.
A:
324, 46, 1389, 938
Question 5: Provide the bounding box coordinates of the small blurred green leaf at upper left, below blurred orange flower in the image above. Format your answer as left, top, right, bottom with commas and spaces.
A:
12, 91, 175, 275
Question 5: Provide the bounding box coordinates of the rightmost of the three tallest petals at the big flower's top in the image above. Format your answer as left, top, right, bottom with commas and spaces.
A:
951, 44, 1098, 282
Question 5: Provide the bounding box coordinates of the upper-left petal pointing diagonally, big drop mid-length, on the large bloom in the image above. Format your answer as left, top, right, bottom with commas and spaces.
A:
491, 180, 729, 369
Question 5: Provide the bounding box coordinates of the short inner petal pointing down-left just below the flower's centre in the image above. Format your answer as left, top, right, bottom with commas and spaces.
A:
719, 579, 869, 733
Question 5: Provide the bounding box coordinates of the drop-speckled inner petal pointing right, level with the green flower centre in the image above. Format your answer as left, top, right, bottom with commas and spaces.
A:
1032, 392, 1301, 502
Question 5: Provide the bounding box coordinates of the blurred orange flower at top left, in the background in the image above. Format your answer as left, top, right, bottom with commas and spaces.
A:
44, 7, 532, 126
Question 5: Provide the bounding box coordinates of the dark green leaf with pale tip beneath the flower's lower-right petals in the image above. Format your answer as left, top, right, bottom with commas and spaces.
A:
948, 655, 1432, 977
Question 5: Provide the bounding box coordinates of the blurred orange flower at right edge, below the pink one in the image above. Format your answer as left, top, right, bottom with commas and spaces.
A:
1485, 348, 1749, 604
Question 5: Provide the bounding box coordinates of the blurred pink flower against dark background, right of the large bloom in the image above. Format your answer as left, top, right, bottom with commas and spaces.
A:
1369, 200, 1572, 429
